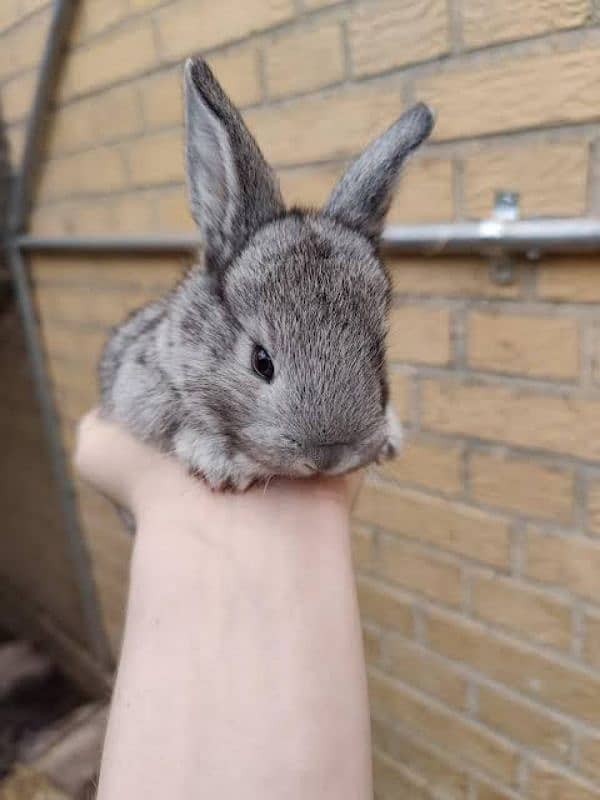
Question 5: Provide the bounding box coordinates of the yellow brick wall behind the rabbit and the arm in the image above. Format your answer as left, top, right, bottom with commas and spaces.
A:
0, 0, 600, 800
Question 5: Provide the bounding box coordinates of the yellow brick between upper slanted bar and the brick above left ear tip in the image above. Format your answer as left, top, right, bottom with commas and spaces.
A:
59, 20, 157, 101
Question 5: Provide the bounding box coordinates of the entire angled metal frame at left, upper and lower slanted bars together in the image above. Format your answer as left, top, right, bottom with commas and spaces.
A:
3, 0, 112, 667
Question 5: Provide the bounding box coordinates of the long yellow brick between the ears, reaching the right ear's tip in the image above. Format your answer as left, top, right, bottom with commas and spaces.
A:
246, 81, 402, 166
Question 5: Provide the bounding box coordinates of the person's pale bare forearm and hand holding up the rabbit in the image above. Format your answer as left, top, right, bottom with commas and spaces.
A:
76, 413, 373, 800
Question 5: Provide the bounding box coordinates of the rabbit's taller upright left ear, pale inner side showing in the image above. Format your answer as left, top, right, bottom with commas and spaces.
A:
184, 59, 284, 270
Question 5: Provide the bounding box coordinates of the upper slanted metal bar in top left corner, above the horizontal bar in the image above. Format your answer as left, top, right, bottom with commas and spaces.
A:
8, 0, 78, 234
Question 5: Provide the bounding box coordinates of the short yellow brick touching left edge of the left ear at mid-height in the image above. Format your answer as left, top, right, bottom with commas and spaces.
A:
125, 130, 184, 186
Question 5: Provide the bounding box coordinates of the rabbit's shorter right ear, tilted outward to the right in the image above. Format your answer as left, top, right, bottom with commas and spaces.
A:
324, 103, 433, 241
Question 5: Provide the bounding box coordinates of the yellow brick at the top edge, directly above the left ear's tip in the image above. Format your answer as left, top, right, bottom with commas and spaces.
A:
157, 0, 294, 60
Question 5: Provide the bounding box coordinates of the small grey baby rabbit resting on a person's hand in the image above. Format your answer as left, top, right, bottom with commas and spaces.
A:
99, 59, 433, 490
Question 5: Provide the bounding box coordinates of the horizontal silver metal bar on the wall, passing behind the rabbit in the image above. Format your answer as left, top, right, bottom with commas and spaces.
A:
18, 218, 600, 258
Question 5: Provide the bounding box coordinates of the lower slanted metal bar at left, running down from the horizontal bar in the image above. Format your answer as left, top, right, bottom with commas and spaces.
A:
6, 243, 111, 666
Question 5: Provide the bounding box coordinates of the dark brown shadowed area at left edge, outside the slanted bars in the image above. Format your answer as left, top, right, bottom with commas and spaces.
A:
0, 101, 94, 656
